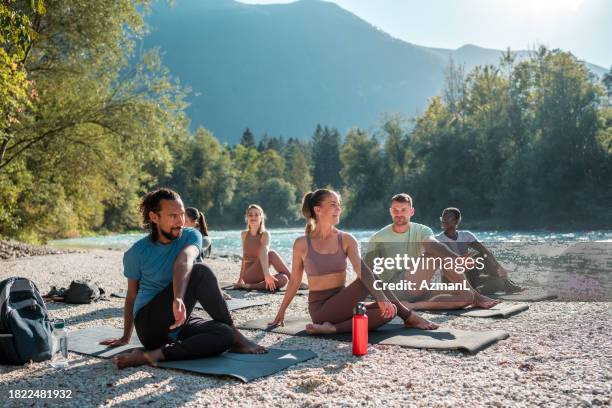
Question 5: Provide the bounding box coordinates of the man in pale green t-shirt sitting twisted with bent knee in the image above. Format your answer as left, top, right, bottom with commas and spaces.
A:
365, 193, 498, 310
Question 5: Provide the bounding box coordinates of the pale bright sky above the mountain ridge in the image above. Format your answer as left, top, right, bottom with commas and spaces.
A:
239, 0, 612, 69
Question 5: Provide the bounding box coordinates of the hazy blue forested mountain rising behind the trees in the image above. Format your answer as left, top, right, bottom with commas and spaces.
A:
144, 0, 606, 144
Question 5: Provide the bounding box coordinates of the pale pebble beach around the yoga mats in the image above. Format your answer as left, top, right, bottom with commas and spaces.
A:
0, 250, 612, 407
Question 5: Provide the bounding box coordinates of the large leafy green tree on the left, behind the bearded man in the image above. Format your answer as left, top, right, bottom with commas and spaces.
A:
0, 0, 186, 240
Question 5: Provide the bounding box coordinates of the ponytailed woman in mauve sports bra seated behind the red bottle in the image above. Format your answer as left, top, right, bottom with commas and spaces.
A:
270, 189, 437, 334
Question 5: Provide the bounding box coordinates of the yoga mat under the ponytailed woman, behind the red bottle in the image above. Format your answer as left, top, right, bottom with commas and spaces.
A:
238, 317, 509, 353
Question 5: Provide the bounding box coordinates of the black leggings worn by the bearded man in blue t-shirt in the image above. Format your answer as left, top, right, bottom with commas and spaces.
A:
134, 264, 234, 360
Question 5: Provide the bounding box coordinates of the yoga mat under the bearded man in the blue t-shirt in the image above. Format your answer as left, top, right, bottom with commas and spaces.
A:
68, 326, 317, 382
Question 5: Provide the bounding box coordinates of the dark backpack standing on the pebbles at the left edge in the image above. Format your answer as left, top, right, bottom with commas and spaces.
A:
0, 278, 52, 365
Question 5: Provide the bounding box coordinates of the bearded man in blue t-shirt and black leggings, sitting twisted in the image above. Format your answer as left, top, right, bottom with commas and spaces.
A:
102, 188, 266, 368
